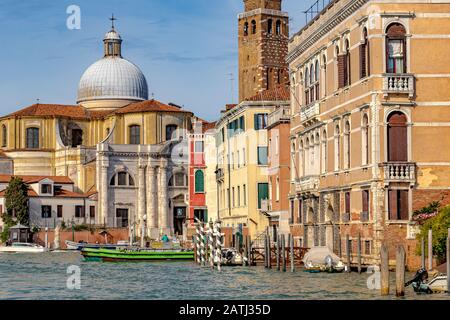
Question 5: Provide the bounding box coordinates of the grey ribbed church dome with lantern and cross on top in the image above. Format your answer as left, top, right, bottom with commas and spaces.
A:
77, 25, 148, 104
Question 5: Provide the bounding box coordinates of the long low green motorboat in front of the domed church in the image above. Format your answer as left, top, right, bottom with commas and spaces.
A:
81, 248, 194, 262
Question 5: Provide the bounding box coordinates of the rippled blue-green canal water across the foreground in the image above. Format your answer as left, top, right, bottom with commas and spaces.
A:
0, 252, 449, 300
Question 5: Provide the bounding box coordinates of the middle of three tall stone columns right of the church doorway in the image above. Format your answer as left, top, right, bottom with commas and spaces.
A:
147, 163, 159, 239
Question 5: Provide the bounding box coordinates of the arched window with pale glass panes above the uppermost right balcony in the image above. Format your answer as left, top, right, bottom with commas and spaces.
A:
386, 23, 407, 73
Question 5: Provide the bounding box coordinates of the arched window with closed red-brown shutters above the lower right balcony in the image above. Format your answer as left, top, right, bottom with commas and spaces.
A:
388, 111, 408, 162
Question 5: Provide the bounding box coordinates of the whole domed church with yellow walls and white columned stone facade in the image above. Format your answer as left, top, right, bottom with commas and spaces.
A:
0, 21, 193, 239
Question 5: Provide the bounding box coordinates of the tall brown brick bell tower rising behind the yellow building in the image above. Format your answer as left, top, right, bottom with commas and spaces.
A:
238, 0, 289, 102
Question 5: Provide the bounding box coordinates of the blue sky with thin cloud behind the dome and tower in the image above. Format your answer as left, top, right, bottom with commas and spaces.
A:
0, 0, 315, 120
